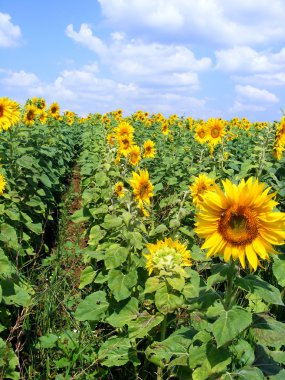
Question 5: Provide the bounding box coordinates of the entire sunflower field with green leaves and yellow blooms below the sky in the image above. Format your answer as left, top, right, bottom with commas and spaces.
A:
0, 98, 285, 380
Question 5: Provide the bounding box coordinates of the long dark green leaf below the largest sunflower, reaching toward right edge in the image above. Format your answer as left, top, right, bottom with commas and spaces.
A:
235, 274, 283, 305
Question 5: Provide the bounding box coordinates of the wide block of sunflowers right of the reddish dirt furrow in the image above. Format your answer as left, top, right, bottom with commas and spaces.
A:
67, 110, 285, 380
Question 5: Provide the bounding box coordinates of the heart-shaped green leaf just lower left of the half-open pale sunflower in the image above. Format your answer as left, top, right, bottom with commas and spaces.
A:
108, 269, 138, 301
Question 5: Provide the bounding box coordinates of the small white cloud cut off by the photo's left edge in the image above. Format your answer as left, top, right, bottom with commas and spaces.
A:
0, 12, 21, 47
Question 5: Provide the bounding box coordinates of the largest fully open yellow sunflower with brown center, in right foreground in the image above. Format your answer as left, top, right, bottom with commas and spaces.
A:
196, 177, 285, 270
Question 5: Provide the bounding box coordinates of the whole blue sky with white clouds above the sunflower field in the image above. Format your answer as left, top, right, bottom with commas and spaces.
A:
0, 0, 285, 121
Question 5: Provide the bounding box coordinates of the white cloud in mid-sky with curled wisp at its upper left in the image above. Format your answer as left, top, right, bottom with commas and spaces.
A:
66, 24, 212, 91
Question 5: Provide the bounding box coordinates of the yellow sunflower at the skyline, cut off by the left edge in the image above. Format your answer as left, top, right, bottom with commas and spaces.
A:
0, 97, 20, 131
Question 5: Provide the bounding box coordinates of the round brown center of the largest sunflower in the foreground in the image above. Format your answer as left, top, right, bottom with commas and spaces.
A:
218, 206, 258, 246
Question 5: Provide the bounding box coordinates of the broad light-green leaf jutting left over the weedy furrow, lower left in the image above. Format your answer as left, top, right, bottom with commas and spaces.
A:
74, 290, 109, 321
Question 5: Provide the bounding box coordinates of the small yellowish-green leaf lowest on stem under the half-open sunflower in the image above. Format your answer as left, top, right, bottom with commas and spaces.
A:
154, 285, 184, 314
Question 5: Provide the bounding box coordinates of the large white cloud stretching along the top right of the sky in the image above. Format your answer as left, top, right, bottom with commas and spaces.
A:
96, 0, 285, 46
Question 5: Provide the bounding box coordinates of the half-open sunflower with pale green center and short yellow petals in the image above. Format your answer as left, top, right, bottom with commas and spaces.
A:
144, 238, 191, 275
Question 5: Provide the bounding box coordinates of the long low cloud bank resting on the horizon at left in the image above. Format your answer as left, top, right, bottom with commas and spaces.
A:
0, 62, 207, 117
